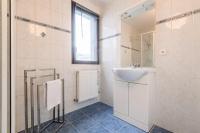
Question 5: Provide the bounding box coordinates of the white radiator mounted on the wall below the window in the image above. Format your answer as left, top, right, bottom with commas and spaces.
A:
75, 70, 99, 102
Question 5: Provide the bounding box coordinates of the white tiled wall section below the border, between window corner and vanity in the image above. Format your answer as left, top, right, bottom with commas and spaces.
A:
101, 36, 120, 105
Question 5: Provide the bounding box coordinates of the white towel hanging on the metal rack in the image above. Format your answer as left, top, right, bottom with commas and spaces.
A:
45, 79, 62, 110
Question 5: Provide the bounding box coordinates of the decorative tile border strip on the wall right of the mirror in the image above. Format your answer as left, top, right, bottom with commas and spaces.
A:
156, 9, 200, 25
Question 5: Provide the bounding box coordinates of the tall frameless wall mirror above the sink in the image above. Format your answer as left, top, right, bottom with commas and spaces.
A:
120, 0, 155, 67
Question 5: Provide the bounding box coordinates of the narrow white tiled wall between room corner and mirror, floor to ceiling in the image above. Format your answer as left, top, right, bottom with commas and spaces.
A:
101, 0, 143, 105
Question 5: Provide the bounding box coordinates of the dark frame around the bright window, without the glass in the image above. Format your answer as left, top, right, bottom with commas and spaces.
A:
71, 1, 100, 65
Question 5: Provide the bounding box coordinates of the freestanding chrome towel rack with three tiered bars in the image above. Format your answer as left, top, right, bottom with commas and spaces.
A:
24, 68, 65, 133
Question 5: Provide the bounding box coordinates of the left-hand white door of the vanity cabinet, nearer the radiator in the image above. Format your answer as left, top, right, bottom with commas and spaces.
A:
114, 81, 128, 116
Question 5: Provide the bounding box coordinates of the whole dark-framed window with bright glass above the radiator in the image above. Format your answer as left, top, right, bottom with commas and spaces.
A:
72, 2, 99, 64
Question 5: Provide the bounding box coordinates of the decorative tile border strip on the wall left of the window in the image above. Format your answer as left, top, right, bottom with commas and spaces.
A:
15, 16, 71, 33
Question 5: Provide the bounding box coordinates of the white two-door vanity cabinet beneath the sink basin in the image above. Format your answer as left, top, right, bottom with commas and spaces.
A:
114, 74, 154, 132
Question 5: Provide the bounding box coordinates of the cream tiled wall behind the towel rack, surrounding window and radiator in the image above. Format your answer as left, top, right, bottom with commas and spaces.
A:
15, 0, 100, 131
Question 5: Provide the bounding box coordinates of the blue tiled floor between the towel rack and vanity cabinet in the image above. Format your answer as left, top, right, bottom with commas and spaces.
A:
19, 103, 172, 133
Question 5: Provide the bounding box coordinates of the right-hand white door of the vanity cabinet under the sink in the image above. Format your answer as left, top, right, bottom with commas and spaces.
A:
129, 84, 149, 124
